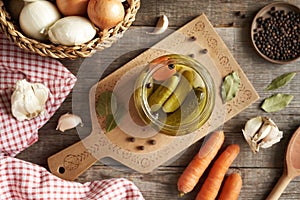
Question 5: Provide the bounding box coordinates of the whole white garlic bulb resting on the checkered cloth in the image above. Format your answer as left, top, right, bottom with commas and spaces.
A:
11, 79, 49, 121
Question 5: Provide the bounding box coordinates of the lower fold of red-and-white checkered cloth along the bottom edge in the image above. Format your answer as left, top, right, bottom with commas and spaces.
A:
0, 155, 144, 200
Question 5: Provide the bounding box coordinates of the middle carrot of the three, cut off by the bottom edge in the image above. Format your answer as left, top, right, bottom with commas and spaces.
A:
196, 144, 240, 200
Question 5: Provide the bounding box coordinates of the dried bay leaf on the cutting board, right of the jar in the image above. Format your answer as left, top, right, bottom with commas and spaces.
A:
221, 72, 241, 102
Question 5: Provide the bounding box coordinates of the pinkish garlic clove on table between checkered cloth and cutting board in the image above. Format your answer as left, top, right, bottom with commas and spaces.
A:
56, 113, 83, 132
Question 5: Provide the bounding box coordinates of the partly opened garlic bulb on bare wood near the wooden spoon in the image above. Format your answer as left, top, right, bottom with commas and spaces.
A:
242, 116, 283, 153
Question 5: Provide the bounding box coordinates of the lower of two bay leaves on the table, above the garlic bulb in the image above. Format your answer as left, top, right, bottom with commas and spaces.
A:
261, 94, 294, 113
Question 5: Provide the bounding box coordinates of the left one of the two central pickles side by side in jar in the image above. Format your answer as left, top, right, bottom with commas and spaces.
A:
148, 74, 180, 112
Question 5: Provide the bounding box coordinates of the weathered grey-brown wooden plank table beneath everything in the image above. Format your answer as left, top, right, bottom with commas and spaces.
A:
17, 0, 300, 200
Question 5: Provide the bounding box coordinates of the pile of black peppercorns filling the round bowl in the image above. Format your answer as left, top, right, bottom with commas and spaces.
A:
253, 7, 300, 61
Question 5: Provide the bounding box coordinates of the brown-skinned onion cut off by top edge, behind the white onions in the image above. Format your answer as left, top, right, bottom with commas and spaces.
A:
56, 0, 89, 16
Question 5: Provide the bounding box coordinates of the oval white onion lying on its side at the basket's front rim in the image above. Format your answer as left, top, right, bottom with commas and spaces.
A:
48, 16, 96, 46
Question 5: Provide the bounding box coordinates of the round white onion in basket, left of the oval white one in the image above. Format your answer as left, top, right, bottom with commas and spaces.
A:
19, 1, 60, 41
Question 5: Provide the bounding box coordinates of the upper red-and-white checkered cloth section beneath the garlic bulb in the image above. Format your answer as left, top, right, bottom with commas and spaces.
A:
0, 33, 76, 156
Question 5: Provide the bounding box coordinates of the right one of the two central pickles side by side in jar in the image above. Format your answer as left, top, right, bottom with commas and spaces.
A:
163, 70, 194, 113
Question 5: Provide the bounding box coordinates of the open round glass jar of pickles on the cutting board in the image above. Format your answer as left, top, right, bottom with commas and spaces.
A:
134, 54, 215, 136
